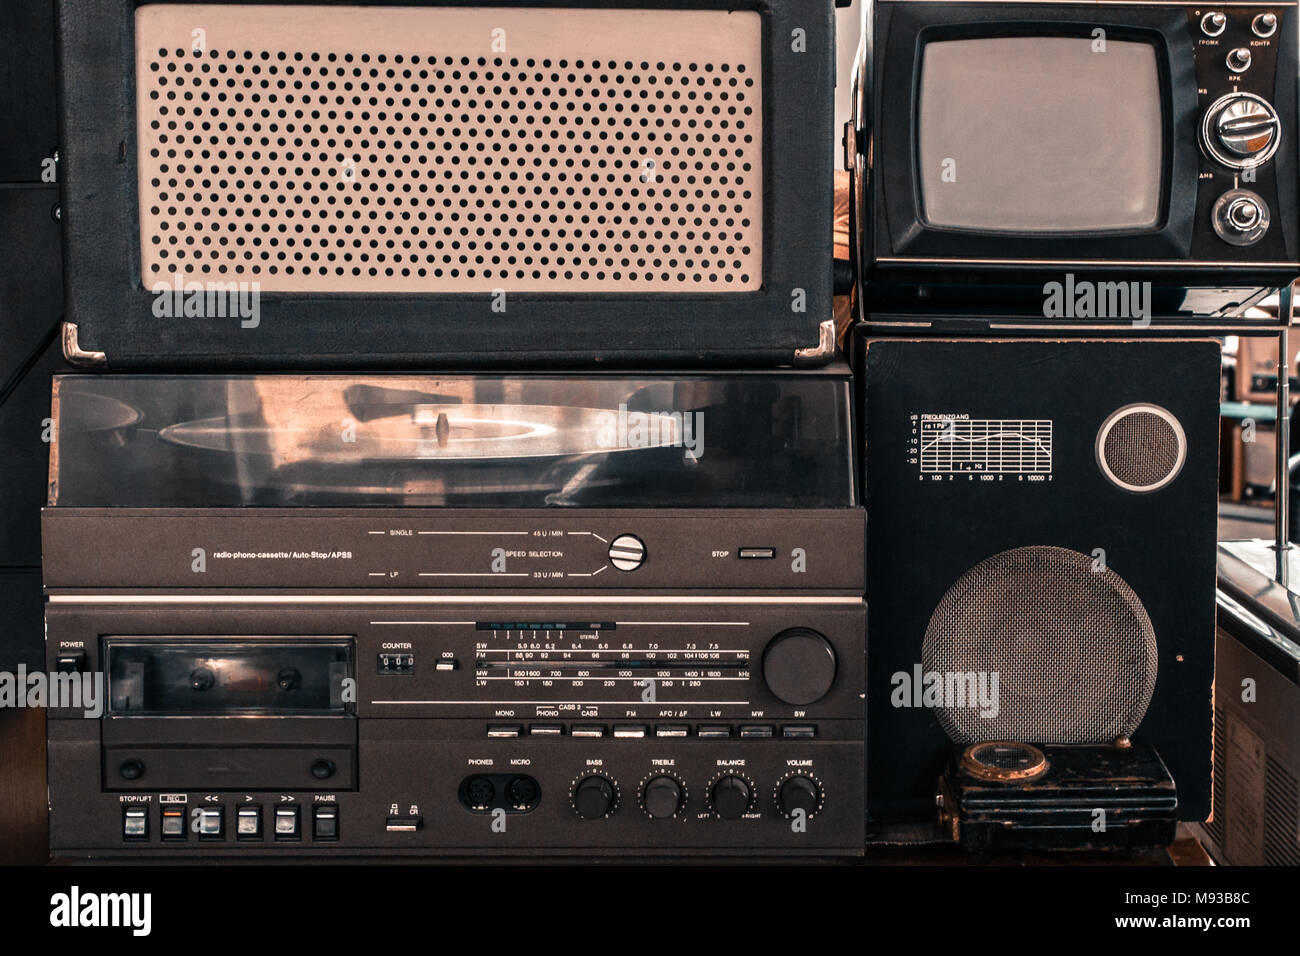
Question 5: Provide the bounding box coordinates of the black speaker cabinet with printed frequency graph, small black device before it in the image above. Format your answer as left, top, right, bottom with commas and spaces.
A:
857, 338, 1219, 848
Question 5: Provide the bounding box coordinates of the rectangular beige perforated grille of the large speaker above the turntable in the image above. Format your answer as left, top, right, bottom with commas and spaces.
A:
137, 4, 763, 293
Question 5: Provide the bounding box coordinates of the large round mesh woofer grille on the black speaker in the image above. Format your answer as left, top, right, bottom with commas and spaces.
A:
922, 545, 1158, 744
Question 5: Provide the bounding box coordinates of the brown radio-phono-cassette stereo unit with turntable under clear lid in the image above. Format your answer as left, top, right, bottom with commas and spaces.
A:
43, 364, 866, 857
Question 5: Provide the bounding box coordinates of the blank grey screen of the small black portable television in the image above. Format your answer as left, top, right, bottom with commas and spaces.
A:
917, 36, 1164, 234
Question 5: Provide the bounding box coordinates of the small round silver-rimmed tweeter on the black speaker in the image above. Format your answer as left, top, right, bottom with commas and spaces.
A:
1097, 402, 1187, 494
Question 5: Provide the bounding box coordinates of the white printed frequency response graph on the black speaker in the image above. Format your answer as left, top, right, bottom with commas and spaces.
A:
919, 415, 1052, 475
